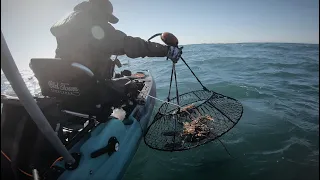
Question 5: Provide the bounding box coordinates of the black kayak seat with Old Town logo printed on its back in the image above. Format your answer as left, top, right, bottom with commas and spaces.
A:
30, 58, 121, 120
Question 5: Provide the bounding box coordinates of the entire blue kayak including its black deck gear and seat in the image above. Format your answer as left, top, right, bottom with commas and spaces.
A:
1, 59, 156, 180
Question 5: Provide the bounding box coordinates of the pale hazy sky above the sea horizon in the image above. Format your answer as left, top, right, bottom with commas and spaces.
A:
1, 0, 319, 67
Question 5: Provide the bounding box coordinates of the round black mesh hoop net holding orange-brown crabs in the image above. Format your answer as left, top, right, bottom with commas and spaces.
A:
144, 90, 243, 151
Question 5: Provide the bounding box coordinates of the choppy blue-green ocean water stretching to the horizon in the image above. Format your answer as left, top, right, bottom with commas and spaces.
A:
1, 43, 319, 180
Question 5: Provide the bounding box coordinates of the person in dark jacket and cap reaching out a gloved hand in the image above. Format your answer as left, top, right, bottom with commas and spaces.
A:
50, 0, 181, 79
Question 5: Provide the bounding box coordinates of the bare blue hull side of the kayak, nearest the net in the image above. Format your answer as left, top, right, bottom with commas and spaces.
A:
56, 70, 156, 180
